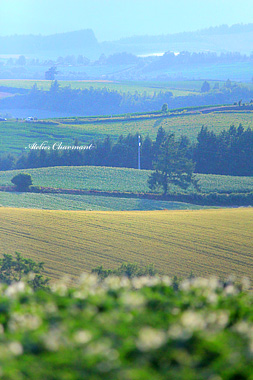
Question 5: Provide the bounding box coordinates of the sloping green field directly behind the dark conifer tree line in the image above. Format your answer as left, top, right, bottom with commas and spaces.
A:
0, 107, 253, 153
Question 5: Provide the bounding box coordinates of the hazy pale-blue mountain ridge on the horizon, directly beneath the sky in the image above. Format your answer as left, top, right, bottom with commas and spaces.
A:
0, 23, 253, 58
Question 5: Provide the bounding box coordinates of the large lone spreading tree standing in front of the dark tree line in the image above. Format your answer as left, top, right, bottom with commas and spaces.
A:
148, 134, 198, 195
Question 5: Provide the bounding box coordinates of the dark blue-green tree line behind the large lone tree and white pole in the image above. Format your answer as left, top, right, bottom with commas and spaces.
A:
0, 124, 253, 176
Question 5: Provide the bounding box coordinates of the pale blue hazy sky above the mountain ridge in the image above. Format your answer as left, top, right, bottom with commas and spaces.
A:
0, 0, 253, 41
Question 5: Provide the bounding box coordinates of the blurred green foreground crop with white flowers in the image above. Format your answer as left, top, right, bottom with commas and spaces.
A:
0, 275, 253, 380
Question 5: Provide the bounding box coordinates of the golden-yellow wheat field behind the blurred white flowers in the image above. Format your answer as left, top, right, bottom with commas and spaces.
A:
0, 207, 253, 280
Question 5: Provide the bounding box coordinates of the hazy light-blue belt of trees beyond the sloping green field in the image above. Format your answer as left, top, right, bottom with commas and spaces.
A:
0, 80, 253, 116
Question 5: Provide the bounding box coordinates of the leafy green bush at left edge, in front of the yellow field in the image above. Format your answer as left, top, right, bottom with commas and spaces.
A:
0, 252, 49, 290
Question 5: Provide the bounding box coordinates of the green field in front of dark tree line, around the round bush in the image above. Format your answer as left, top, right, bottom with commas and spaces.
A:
0, 166, 253, 193
